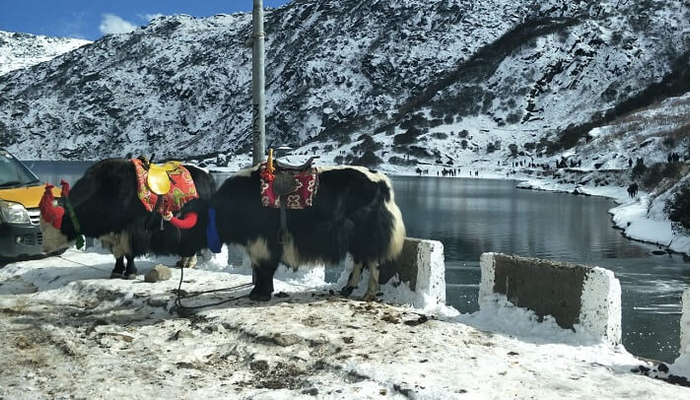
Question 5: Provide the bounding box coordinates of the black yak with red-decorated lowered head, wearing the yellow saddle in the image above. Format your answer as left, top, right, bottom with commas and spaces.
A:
41, 158, 216, 278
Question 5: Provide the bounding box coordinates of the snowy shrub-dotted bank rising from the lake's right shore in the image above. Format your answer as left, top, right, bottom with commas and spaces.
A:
516, 94, 690, 255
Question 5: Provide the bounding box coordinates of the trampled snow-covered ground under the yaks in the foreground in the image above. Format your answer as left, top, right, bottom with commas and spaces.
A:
0, 250, 689, 399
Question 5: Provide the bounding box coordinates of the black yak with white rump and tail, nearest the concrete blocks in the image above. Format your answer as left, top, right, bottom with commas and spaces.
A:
185, 166, 405, 301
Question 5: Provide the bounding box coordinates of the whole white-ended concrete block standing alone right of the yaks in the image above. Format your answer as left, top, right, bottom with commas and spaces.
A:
479, 253, 622, 343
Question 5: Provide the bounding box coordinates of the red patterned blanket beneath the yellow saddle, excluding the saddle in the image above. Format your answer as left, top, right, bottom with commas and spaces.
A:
131, 158, 199, 219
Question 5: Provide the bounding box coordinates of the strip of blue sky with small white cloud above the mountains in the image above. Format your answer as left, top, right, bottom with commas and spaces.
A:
0, 0, 290, 40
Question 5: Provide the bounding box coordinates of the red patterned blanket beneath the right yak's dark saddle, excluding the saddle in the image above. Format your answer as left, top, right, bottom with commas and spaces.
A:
260, 166, 318, 210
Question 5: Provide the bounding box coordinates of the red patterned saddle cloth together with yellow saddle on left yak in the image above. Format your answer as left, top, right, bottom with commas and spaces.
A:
131, 158, 199, 219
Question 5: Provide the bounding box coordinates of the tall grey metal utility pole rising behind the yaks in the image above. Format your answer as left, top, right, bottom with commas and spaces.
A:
253, 0, 265, 165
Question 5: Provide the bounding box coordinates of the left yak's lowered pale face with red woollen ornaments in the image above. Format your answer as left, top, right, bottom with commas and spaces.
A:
39, 181, 76, 253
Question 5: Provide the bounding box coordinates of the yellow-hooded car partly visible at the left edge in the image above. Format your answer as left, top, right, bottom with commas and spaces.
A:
0, 148, 65, 260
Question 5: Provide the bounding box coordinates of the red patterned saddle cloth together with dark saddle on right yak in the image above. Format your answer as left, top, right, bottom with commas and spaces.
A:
260, 164, 318, 210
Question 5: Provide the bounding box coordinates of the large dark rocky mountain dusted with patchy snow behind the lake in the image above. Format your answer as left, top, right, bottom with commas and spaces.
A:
0, 0, 690, 165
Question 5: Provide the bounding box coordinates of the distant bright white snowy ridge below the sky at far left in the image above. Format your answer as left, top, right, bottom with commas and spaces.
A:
0, 31, 91, 75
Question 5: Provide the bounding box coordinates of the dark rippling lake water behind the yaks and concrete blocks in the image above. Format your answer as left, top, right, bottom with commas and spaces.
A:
21, 161, 690, 361
